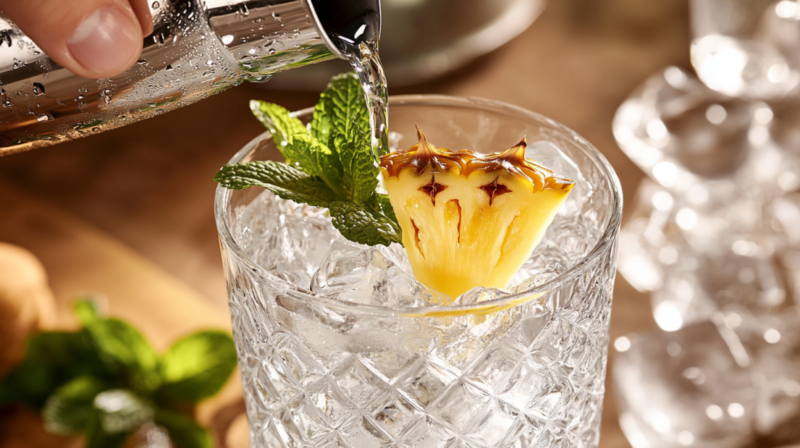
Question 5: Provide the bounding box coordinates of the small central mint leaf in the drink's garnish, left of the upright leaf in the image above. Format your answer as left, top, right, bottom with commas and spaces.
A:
285, 134, 344, 195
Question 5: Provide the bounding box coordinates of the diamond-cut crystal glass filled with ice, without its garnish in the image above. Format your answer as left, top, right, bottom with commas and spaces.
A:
215, 95, 622, 448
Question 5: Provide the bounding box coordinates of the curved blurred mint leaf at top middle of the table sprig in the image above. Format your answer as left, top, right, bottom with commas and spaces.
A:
86, 319, 160, 392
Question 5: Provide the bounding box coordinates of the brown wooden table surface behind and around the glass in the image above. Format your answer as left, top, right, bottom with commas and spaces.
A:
0, 0, 689, 448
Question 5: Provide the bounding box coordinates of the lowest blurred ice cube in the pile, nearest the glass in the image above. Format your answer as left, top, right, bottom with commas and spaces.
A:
613, 322, 758, 448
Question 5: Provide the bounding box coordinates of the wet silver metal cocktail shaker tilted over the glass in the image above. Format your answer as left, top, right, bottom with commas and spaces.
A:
0, 0, 380, 155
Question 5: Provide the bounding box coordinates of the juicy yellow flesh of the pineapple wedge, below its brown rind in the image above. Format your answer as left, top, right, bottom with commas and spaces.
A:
382, 159, 573, 299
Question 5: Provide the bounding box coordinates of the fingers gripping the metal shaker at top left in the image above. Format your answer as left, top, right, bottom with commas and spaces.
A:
0, 0, 153, 78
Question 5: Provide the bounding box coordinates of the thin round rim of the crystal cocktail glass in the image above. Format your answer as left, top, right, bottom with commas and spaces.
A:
214, 95, 622, 317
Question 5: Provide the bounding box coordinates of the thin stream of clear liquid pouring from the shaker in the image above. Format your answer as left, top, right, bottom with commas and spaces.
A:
342, 42, 389, 163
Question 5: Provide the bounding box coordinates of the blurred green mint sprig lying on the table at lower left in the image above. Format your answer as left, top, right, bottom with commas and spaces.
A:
0, 300, 236, 448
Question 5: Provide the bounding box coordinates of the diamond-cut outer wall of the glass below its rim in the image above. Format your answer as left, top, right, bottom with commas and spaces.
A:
230, 226, 613, 448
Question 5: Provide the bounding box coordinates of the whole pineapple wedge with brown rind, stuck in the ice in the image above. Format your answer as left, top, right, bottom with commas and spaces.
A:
380, 128, 575, 299
